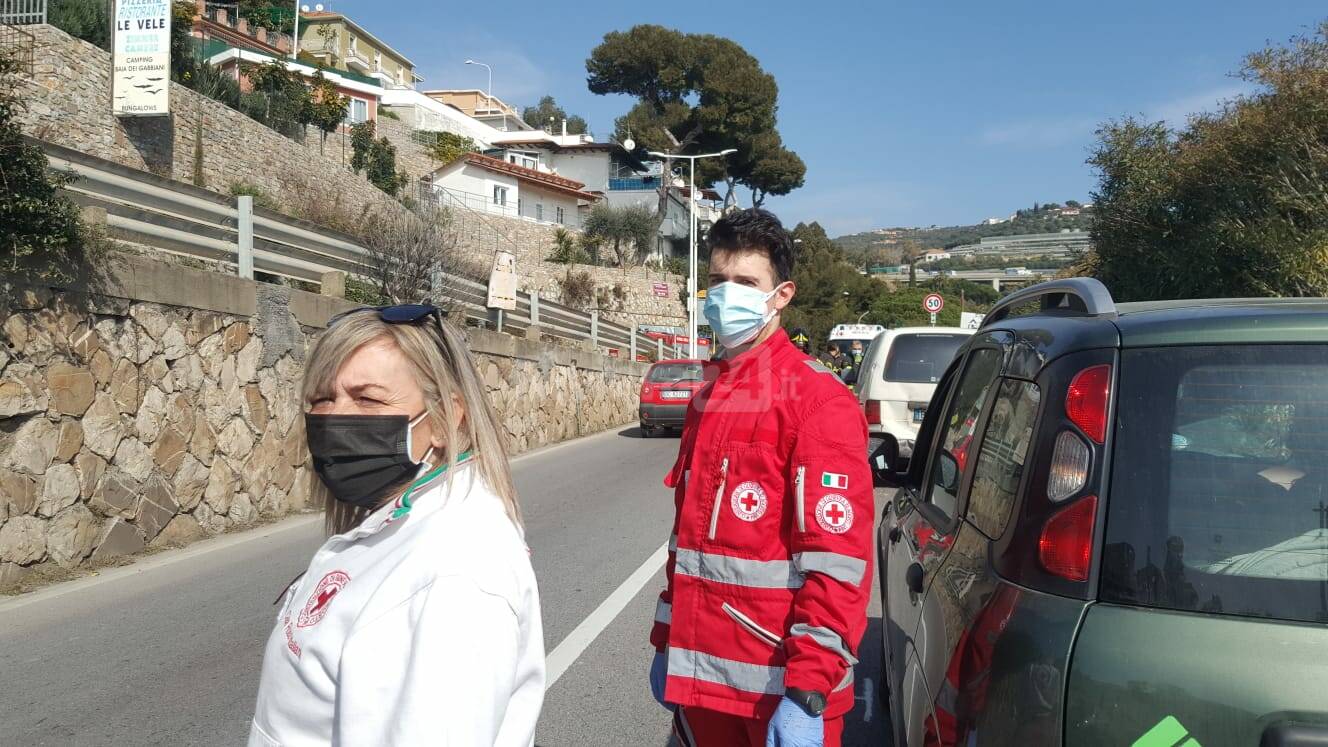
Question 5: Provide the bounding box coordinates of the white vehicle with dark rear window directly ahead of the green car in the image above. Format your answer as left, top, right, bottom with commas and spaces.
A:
857, 327, 973, 465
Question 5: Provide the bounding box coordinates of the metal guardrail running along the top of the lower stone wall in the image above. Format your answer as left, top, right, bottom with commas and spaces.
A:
31, 140, 683, 359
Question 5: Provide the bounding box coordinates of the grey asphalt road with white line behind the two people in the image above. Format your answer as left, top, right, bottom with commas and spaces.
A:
0, 428, 887, 747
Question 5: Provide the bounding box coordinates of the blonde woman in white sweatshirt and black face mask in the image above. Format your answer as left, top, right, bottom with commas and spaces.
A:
250, 304, 544, 747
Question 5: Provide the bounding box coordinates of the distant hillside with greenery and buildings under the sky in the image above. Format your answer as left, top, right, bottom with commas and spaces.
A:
834, 199, 1093, 267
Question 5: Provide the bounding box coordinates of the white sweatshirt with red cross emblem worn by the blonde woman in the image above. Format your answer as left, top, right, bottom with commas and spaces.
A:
248, 465, 544, 747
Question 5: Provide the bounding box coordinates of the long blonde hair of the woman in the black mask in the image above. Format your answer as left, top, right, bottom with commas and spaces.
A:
303, 311, 522, 534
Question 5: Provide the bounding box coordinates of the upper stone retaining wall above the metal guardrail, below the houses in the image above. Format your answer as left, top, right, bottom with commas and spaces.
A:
17, 25, 685, 326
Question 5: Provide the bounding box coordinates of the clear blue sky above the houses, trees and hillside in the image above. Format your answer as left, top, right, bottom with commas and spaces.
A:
331, 0, 1328, 235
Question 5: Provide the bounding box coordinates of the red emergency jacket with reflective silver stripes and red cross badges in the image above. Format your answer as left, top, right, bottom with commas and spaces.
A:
651, 331, 874, 718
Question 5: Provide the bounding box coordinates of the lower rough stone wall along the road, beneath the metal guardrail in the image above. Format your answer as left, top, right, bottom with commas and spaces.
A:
0, 257, 644, 586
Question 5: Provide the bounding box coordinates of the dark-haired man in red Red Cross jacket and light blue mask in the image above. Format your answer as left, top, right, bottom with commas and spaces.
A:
651, 209, 875, 747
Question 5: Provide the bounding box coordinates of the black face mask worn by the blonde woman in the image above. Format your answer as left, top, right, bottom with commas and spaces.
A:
304, 415, 422, 508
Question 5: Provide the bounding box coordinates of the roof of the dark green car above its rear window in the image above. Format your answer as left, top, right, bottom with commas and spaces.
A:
1114, 298, 1328, 347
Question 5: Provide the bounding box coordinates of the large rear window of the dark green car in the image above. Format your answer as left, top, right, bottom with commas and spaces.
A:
1102, 346, 1328, 622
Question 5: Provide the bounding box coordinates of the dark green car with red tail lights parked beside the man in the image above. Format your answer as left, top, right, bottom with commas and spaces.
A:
874, 279, 1328, 747
